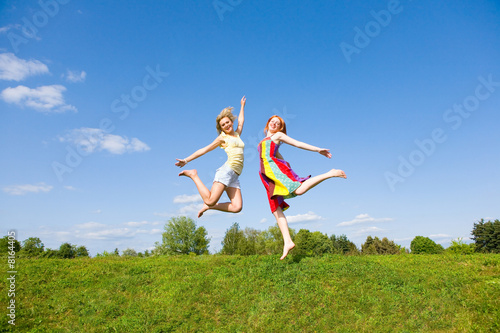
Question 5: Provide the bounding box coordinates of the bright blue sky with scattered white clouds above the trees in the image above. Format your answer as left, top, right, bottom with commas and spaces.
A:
0, 0, 500, 255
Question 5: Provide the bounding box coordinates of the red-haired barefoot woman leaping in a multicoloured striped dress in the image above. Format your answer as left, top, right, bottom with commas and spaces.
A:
258, 116, 347, 260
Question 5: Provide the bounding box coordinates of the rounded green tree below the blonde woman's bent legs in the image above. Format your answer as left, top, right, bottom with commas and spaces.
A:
157, 216, 210, 254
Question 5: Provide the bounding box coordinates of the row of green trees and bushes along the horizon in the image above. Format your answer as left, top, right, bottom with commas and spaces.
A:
0, 216, 500, 259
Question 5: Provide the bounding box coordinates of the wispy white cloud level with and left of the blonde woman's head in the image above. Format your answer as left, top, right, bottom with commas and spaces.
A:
59, 128, 150, 155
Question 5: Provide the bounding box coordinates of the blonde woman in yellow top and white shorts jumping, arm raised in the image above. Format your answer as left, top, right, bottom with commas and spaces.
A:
175, 96, 246, 217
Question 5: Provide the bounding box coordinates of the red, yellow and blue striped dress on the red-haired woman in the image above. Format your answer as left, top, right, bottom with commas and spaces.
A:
258, 138, 311, 212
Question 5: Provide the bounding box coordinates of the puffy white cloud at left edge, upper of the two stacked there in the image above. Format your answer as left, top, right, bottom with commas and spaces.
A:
0, 53, 49, 81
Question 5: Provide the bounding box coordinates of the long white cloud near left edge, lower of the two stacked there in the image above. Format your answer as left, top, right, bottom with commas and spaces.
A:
0, 85, 77, 113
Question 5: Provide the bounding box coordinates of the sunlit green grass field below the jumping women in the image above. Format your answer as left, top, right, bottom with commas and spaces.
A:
0, 254, 500, 332
